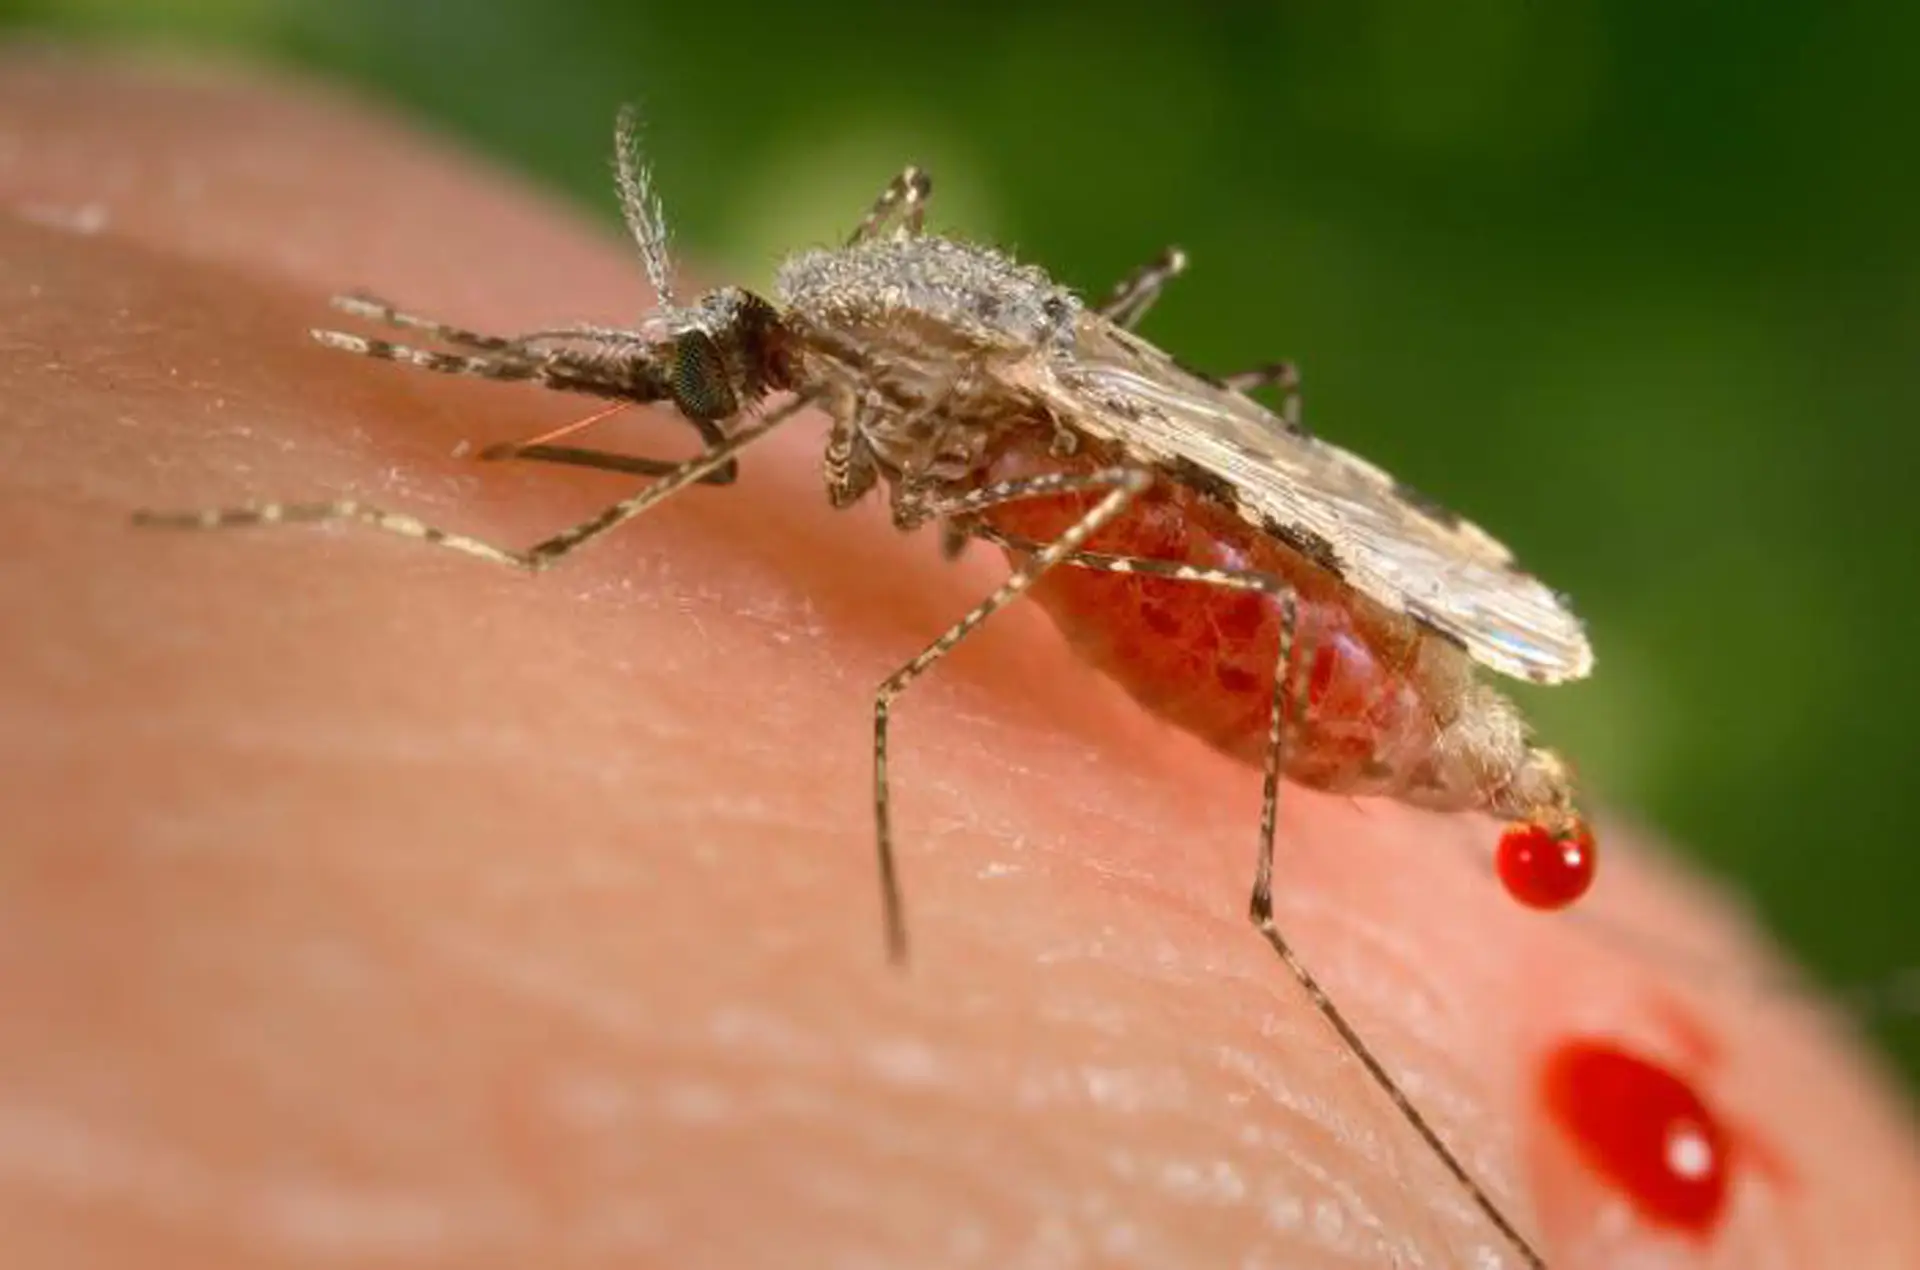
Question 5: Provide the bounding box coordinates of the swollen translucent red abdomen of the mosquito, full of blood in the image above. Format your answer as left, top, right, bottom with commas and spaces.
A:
981, 453, 1440, 794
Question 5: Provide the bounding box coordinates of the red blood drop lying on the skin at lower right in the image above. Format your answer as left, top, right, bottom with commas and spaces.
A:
1540, 1039, 1732, 1235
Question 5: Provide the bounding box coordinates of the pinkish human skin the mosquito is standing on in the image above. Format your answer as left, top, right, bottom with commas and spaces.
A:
0, 54, 1920, 1270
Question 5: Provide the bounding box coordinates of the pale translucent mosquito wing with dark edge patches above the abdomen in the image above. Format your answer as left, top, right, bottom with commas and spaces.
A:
1012, 315, 1594, 684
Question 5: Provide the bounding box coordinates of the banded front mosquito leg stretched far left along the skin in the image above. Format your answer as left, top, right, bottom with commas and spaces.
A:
132, 398, 810, 573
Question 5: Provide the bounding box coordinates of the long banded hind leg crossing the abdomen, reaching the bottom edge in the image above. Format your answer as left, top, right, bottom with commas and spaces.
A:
972, 525, 1546, 1270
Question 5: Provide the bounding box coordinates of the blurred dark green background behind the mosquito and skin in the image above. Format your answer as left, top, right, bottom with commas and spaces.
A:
0, 0, 1920, 1078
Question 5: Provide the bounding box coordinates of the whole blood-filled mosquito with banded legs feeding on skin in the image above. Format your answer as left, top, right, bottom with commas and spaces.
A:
134, 110, 1594, 1270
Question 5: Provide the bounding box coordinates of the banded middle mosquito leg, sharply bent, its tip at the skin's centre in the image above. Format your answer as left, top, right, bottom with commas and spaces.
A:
874, 467, 1154, 965
